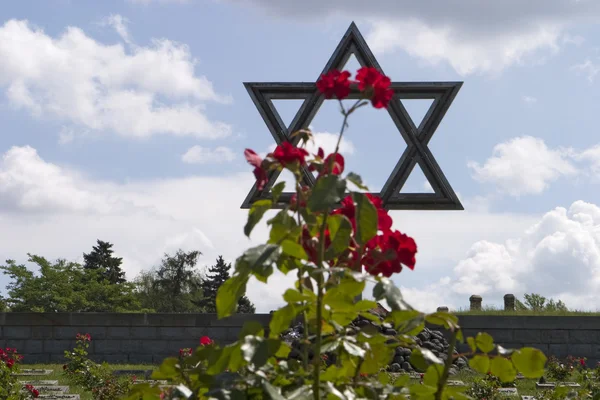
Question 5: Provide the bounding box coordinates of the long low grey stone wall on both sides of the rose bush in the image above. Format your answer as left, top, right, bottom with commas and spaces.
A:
0, 313, 600, 364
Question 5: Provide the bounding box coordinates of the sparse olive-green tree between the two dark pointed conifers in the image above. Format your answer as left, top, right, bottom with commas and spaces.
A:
135, 249, 203, 312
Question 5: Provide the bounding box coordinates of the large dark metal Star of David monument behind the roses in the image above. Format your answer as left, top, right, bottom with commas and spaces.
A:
242, 22, 464, 210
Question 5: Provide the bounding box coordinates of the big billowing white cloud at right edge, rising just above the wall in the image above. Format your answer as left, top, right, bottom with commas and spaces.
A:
436, 201, 600, 310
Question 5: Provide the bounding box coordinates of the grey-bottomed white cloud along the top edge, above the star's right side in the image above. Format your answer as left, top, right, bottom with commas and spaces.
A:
224, 0, 600, 75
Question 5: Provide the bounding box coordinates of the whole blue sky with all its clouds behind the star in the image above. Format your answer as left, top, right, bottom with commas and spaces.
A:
0, 0, 600, 311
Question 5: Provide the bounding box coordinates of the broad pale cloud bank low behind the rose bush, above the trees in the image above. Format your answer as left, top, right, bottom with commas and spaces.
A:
0, 147, 531, 312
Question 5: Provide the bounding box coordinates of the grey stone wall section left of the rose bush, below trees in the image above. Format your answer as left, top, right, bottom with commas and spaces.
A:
0, 313, 270, 364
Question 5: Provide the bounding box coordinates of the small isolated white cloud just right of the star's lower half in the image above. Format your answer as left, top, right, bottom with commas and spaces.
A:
467, 136, 577, 197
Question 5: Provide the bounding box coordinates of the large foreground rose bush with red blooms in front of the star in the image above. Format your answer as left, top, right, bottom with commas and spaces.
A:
129, 68, 546, 399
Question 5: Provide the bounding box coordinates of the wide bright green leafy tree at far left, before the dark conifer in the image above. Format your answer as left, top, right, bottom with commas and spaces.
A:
0, 254, 139, 312
